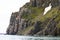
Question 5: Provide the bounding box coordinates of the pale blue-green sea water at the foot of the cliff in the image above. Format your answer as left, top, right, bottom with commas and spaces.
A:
0, 35, 60, 40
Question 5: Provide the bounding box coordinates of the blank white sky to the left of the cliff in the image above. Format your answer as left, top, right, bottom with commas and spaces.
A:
0, 0, 30, 33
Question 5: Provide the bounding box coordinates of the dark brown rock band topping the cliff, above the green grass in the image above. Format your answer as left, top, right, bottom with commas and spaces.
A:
30, 0, 60, 7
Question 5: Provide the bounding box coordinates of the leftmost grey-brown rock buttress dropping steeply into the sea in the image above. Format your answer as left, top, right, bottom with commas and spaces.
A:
7, 12, 19, 34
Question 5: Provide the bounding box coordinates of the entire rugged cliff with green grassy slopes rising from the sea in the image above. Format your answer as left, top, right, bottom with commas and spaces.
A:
7, 0, 60, 36
